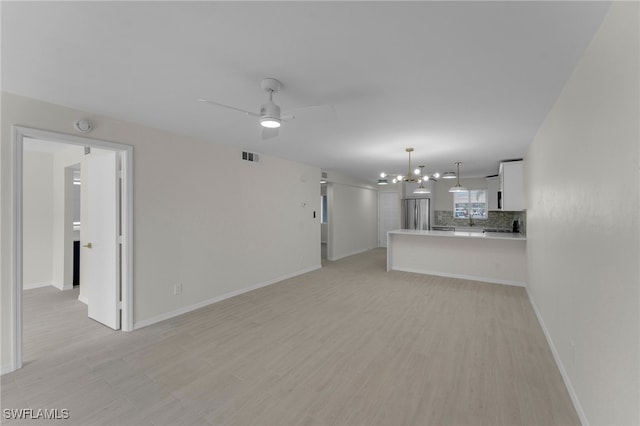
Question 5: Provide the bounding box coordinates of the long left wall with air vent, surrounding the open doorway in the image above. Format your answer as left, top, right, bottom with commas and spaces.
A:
0, 92, 320, 369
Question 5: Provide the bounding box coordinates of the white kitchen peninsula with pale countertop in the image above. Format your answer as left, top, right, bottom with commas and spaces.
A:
387, 229, 527, 286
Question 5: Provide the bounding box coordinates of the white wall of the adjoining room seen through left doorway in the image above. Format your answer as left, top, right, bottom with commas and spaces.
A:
22, 151, 53, 289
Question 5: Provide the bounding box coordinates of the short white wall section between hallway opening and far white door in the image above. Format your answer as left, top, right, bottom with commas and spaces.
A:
327, 171, 378, 260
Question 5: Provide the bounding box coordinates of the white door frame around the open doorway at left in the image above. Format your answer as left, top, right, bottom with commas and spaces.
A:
10, 126, 134, 373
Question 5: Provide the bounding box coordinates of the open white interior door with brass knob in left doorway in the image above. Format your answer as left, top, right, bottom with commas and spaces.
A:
81, 152, 120, 330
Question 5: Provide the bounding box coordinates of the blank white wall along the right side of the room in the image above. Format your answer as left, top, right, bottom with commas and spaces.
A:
525, 2, 640, 425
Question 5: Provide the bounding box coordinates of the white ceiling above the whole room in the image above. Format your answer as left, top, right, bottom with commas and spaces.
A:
2, 1, 609, 182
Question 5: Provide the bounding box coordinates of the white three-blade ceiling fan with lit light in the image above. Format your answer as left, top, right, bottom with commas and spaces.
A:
198, 78, 333, 139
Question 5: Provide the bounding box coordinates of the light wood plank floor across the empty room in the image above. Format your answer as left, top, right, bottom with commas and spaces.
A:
1, 249, 579, 425
